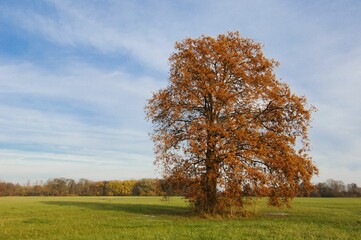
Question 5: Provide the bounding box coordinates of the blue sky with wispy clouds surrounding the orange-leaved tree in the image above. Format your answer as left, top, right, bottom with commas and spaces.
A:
0, 0, 361, 185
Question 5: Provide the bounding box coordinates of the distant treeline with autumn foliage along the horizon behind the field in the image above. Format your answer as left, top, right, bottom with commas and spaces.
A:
0, 178, 361, 197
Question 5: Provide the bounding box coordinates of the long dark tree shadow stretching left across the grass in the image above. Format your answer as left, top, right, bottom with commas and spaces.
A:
42, 201, 194, 216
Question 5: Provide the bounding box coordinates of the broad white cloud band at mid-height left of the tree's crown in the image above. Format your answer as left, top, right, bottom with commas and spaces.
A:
0, 60, 161, 112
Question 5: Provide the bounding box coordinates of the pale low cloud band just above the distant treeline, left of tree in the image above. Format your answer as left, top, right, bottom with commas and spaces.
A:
0, 150, 156, 183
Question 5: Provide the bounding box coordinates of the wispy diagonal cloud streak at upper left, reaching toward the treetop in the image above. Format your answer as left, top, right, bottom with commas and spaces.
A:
2, 1, 173, 71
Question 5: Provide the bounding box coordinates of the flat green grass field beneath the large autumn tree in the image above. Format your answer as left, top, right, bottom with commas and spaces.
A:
0, 197, 361, 240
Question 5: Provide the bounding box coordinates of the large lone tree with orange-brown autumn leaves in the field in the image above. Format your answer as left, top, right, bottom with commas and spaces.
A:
145, 32, 318, 214
